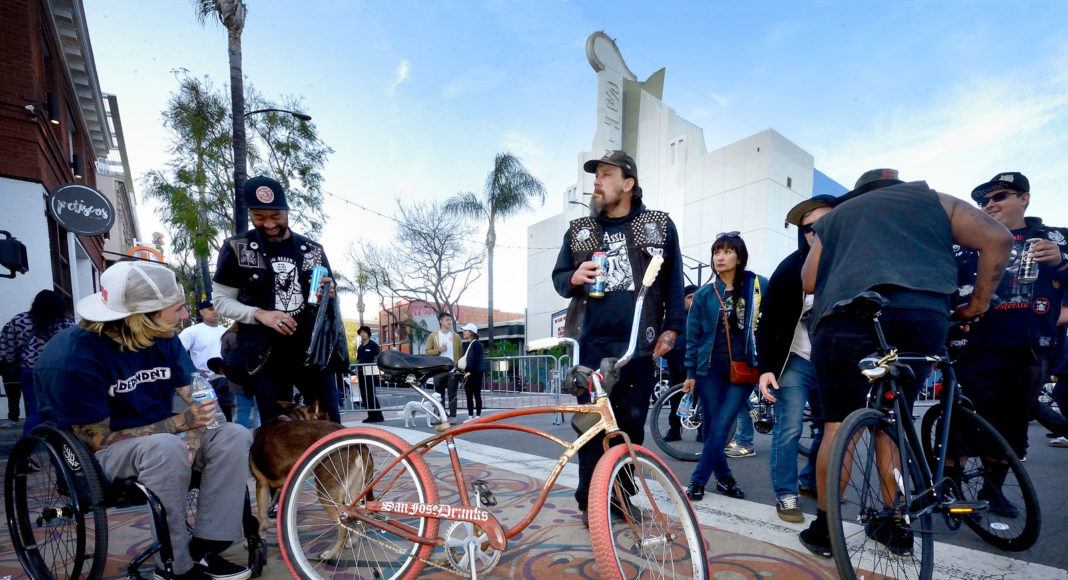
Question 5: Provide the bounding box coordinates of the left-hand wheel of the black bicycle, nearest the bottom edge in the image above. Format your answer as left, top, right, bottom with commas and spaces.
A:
827, 409, 935, 580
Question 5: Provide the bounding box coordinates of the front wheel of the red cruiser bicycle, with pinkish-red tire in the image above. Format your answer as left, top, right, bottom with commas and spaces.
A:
587, 445, 709, 579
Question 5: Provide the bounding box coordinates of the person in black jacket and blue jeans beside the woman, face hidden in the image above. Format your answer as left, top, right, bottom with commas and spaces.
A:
756, 194, 837, 522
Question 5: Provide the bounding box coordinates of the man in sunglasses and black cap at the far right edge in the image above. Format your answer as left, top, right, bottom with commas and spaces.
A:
955, 172, 1068, 463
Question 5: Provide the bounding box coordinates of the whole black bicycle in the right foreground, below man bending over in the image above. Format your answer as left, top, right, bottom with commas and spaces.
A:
826, 293, 1041, 579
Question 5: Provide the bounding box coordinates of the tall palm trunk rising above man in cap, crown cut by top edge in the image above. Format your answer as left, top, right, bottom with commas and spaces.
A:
193, 0, 249, 234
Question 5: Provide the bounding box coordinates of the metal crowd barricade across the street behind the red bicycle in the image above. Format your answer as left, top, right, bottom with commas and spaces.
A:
341, 355, 570, 423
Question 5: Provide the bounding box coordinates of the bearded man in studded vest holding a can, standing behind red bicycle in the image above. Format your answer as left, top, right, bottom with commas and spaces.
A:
552, 151, 686, 527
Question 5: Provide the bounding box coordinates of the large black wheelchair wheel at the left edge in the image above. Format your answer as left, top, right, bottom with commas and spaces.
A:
4, 425, 108, 579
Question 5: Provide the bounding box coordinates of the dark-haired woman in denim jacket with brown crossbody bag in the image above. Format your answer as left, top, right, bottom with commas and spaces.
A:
682, 232, 768, 501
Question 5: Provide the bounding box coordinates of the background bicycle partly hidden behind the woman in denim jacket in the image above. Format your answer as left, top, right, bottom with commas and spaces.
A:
646, 383, 817, 461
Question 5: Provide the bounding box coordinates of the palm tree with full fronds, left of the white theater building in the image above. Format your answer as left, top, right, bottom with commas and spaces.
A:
444, 153, 545, 348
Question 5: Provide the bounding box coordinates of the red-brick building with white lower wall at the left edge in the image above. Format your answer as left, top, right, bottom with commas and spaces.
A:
0, 0, 138, 323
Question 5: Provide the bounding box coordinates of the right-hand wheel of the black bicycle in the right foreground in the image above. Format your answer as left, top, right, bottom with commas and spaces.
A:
921, 403, 1042, 551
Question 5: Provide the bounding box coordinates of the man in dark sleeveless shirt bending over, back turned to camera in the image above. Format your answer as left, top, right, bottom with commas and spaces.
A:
798, 169, 1012, 558
